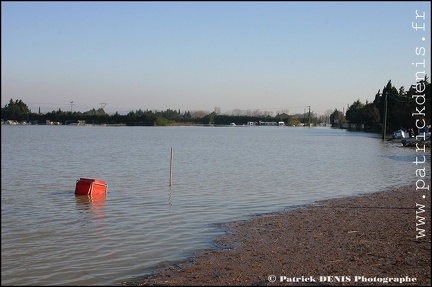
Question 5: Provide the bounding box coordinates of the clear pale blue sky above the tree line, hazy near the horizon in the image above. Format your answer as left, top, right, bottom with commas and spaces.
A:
1, 1, 431, 114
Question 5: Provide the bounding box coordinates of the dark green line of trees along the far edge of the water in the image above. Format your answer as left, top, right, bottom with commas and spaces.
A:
1, 80, 431, 132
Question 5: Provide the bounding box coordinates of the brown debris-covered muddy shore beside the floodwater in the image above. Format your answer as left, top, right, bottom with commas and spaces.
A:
123, 184, 431, 286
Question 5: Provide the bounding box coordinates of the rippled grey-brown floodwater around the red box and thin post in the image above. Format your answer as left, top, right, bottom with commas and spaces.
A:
1, 126, 430, 285
